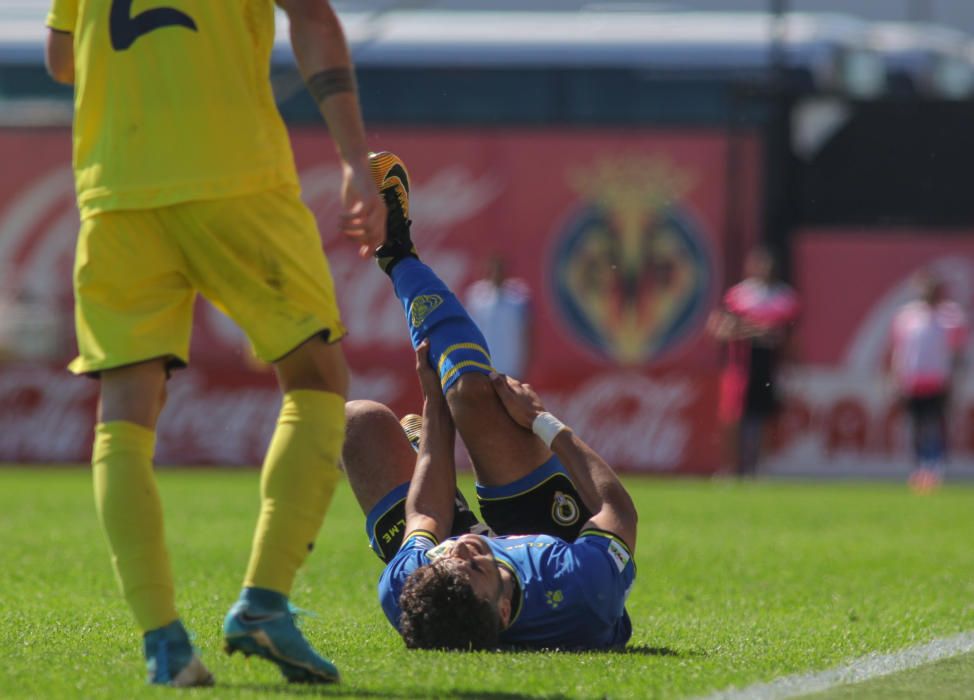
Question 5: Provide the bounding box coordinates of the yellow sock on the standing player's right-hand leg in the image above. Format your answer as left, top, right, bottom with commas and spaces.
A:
244, 390, 345, 595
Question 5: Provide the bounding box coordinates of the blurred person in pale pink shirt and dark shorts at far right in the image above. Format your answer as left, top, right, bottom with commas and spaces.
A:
889, 271, 967, 491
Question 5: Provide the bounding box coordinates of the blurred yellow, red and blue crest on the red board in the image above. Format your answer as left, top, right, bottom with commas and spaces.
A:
551, 157, 710, 365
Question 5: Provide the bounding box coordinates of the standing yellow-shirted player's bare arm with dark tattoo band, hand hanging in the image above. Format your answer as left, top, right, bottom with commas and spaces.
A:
277, 0, 386, 255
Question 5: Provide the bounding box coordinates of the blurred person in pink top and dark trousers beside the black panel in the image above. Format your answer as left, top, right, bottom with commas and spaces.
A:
707, 247, 800, 476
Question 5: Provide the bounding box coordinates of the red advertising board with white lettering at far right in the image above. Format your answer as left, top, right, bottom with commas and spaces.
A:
768, 229, 974, 476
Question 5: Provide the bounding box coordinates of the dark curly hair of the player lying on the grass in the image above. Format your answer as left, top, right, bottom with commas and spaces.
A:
399, 559, 501, 651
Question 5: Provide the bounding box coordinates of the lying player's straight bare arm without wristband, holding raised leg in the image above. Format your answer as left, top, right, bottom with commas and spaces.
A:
406, 341, 457, 541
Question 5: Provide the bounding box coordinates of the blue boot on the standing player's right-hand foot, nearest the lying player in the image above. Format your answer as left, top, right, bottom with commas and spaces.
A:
223, 600, 340, 683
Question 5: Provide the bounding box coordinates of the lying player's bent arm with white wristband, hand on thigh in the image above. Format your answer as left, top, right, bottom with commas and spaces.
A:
491, 374, 637, 552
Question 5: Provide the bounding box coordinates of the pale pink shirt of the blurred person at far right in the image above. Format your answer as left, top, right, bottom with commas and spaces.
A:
891, 301, 967, 396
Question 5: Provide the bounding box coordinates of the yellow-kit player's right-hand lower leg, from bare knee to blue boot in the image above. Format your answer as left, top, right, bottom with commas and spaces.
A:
224, 337, 348, 683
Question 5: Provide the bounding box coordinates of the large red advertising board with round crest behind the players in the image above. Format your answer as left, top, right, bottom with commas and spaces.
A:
0, 129, 759, 472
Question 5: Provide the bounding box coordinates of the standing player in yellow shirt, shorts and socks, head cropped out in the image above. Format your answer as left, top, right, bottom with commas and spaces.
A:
46, 0, 386, 686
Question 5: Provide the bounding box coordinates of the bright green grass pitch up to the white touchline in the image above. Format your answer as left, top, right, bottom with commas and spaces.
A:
0, 469, 974, 698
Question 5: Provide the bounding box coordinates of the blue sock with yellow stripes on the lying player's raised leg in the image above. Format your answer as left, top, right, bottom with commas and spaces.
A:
391, 258, 493, 392
